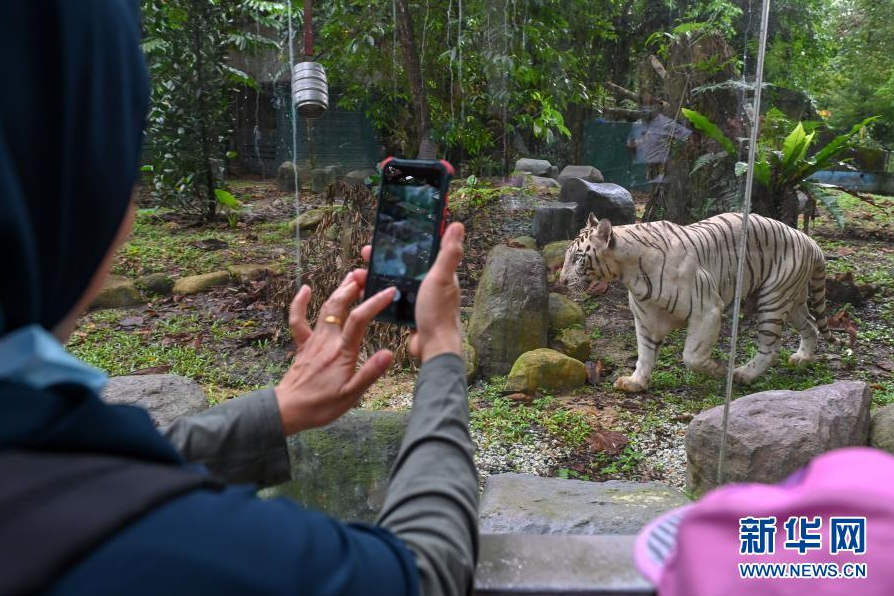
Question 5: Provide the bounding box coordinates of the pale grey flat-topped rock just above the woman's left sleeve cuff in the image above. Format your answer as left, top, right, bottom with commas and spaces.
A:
102, 375, 208, 427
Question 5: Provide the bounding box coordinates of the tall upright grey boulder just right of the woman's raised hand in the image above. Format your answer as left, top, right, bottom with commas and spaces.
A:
469, 245, 549, 376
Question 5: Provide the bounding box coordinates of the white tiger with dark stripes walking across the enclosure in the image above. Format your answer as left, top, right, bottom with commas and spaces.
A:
559, 213, 842, 393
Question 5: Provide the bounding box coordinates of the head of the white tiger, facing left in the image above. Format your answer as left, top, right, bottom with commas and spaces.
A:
559, 213, 619, 293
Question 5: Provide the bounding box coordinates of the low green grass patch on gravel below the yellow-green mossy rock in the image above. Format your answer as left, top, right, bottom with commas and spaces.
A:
470, 377, 592, 447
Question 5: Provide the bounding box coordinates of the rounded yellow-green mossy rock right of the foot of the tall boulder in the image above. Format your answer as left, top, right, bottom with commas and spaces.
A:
506, 348, 587, 394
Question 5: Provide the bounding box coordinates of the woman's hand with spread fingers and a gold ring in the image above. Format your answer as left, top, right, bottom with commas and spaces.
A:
274, 270, 395, 436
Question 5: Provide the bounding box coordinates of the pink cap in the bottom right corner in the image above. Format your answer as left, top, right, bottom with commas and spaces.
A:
635, 447, 894, 596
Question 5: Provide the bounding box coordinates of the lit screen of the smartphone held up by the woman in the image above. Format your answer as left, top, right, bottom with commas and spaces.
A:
373, 174, 440, 281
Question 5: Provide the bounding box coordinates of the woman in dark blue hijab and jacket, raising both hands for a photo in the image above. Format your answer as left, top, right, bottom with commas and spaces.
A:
0, 0, 477, 596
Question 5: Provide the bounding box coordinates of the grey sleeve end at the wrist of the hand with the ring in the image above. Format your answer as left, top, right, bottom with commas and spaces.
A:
161, 389, 291, 487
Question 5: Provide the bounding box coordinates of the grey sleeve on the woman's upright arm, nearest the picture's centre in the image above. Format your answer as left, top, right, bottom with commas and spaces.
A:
378, 354, 478, 596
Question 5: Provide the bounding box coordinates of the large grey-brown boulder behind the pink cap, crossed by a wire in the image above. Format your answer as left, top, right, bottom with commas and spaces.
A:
686, 381, 871, 495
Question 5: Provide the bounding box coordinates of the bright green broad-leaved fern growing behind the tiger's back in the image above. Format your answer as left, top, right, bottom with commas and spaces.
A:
683, 109, 877, 232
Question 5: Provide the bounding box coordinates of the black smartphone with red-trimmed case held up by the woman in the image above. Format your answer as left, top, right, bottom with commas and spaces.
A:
366, 157, 454, 327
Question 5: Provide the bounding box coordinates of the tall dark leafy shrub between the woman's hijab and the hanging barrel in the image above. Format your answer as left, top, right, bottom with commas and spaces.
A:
141, 0, 282, 221
